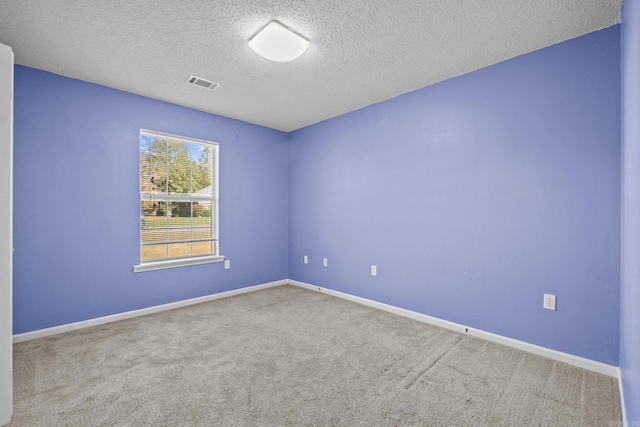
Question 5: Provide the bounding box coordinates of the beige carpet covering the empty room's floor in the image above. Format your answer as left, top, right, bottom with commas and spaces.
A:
10, 286, 621, 427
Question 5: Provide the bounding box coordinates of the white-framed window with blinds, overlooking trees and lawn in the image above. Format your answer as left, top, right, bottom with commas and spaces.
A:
134, 129, 223, 272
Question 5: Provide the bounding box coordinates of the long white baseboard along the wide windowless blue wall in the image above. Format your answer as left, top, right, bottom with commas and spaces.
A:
287, 280, 620, 378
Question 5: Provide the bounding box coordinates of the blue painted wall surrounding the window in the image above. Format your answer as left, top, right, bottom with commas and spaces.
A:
14, 66, 288, 333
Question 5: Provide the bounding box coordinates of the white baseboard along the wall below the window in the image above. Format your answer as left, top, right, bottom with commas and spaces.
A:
13, 280, 290, 343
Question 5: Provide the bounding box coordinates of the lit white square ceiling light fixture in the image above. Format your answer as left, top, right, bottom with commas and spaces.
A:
249, 21, 309, 62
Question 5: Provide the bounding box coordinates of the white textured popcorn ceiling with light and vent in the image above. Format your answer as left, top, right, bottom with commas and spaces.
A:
0, 0, 622, 131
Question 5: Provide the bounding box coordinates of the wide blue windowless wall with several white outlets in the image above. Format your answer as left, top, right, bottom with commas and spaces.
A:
289, 26, 620, 365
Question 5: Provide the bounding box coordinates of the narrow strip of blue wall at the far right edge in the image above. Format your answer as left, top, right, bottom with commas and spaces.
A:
620, 1, 640, 424
